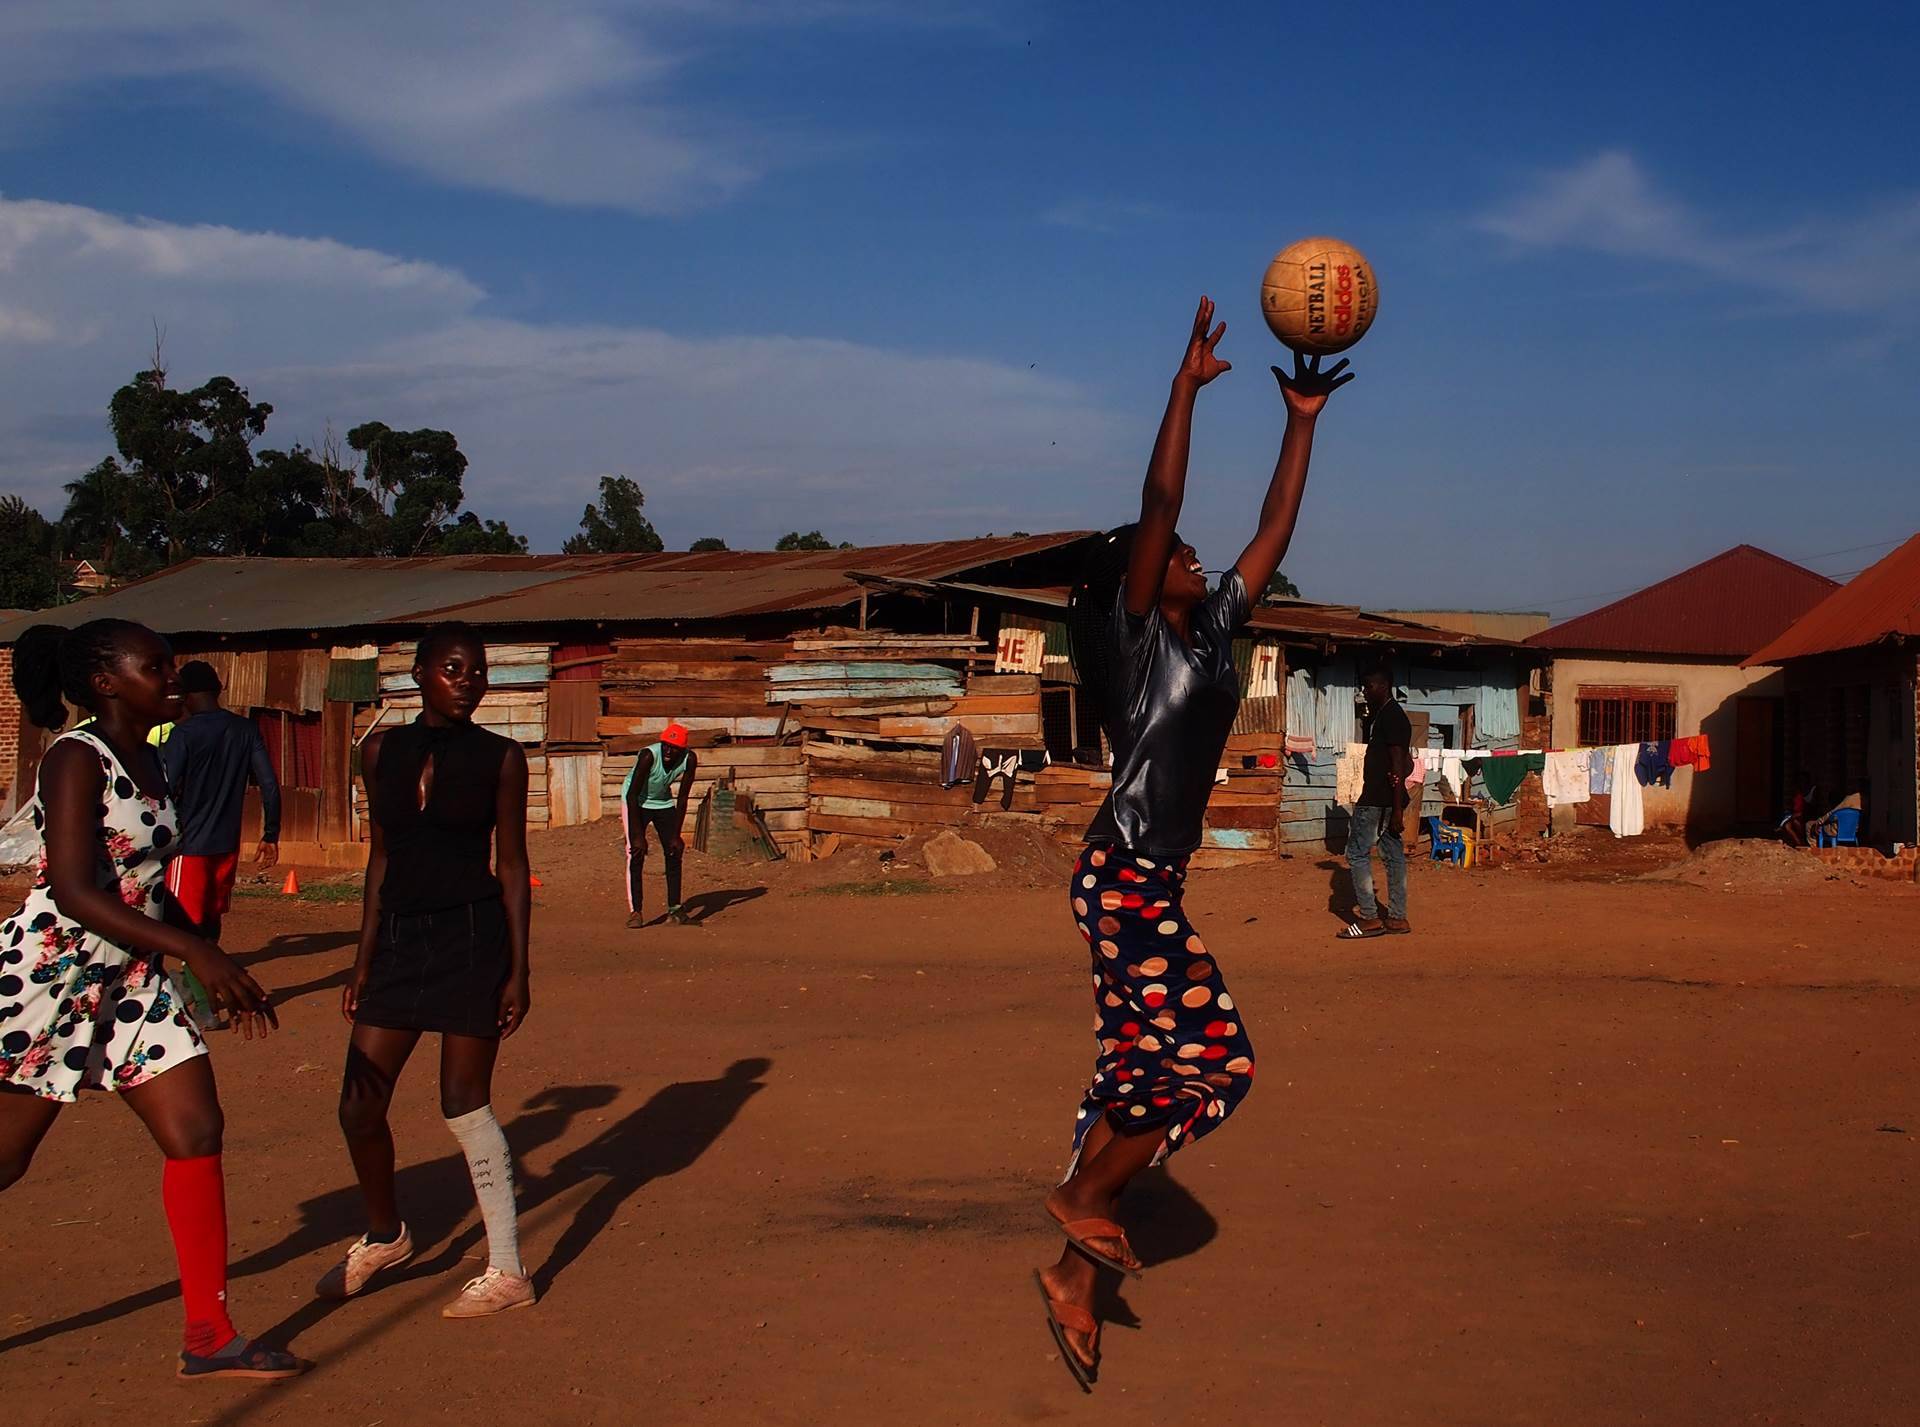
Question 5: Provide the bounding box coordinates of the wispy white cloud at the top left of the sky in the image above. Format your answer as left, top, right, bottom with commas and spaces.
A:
0, 0, 1013, 213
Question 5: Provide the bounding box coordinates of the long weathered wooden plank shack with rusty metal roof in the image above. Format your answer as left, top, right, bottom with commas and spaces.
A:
0, 530, 1540, 866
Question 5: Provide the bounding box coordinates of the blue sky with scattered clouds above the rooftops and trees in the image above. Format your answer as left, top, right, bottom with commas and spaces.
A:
0, 0, 1920, 617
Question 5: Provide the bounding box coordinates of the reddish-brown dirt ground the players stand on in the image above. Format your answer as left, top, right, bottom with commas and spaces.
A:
0, 828, 1920, 1427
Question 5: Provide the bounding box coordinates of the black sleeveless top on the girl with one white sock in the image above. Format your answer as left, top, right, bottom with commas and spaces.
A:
369, 718, 511, 916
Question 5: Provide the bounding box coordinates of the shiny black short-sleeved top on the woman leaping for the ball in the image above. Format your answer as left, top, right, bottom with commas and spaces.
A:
1087, 570, 1252, 857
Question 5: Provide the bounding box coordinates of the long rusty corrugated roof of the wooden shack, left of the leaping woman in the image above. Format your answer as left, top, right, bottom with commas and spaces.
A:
0, 530, 1089, 643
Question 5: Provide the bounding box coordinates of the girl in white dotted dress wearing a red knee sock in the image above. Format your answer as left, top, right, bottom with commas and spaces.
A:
0, 618, 301, 1379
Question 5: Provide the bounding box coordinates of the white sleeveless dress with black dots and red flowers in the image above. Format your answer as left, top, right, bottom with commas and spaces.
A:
0, 730, 207, 1100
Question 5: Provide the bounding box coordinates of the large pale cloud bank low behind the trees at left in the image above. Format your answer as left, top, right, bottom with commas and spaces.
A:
0, 198, 1131, 547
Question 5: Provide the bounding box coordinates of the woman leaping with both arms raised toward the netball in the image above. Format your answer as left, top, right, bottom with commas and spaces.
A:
1035, 298, 1354, 1391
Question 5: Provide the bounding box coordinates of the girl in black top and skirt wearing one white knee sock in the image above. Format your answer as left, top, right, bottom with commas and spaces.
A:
315, 624, 534, 1318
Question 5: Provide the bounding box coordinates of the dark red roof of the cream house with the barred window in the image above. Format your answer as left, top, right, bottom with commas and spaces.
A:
1526, 545, 1837, 659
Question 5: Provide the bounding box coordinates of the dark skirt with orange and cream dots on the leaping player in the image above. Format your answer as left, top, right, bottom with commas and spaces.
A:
1068, 845, 1254, 1164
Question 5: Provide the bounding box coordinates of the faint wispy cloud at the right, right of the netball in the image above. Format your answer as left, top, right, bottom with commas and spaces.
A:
1476, 150, 1920, 313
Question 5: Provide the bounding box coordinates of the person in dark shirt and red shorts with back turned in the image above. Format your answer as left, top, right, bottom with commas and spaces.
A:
159, 659, 280, 941
